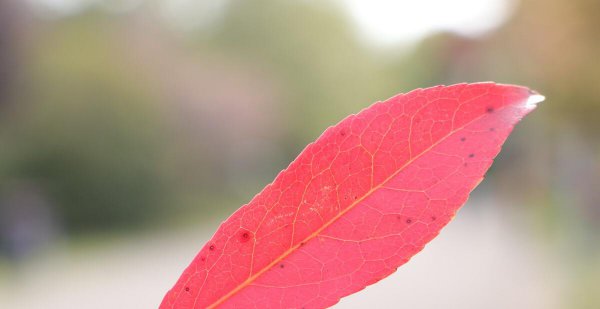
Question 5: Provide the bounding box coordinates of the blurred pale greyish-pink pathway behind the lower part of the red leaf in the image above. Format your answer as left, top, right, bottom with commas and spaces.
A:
0, 202, 562, 309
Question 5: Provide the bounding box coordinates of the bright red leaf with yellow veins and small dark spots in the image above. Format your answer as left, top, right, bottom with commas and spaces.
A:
161, 83, 543, 308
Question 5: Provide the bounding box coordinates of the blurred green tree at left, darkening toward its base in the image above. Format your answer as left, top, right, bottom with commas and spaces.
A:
3, 15, 176, 230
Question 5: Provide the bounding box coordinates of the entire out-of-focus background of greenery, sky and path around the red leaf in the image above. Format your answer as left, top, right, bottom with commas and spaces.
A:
0, 0, 600, 308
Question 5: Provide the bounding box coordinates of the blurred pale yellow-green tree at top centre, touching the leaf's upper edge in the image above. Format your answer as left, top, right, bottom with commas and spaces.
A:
214, 0, 390, 148
